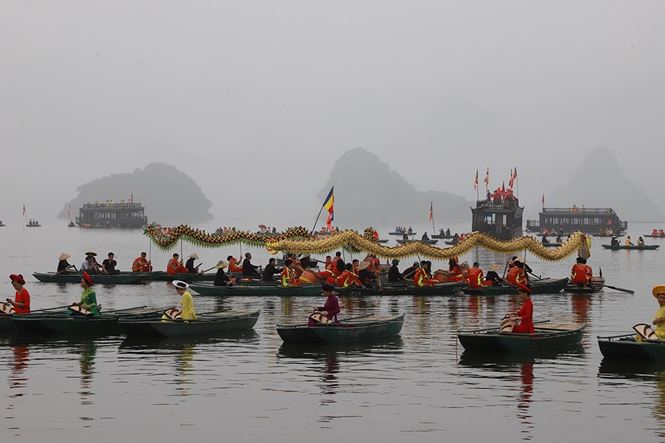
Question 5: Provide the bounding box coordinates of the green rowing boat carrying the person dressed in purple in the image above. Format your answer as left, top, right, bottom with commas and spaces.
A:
277, 314, 404, 344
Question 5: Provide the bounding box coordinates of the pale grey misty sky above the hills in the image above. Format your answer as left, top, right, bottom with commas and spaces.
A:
0, 0, 665, 223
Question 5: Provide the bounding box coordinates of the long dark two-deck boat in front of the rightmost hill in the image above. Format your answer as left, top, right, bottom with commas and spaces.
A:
526, 205, 628, 237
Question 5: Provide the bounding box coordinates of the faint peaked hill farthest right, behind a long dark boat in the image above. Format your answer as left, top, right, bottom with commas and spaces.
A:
545, 147, 665, 221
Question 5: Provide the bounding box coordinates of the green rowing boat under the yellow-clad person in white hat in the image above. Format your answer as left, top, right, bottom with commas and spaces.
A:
118, 311, 260, 337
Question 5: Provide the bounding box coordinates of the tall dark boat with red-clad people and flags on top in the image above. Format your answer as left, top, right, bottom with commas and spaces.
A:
471, 191, 524, 240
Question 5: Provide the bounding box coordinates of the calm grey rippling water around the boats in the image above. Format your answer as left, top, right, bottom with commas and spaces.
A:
0, 221, 665, 442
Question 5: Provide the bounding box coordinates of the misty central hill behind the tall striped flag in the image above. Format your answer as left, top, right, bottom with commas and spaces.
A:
321, 148, 471, 227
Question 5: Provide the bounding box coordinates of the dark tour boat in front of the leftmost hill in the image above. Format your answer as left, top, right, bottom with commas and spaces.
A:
76, 200, 148, 229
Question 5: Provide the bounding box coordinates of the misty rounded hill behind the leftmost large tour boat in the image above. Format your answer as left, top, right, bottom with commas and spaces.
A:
58, 163, 213, 224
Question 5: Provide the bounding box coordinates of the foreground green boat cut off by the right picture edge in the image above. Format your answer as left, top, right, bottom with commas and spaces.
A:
598, 334, 665, 362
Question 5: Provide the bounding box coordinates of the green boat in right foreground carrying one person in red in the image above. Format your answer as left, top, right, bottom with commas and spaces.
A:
457, 322, 585, 352
